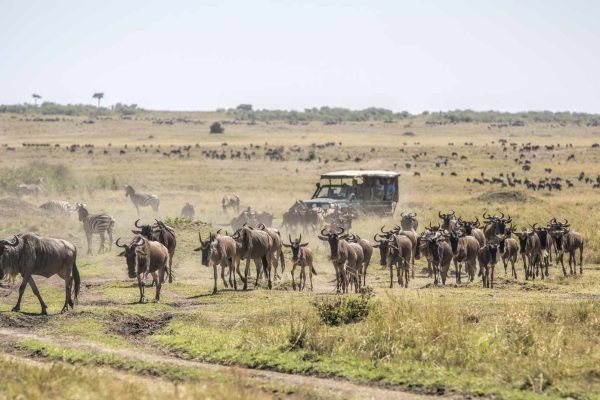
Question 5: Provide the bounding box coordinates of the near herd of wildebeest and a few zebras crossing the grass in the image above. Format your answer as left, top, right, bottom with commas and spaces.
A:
0, 186, 584, 314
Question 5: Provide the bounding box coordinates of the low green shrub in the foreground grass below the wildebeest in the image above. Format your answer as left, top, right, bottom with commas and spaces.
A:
313, 288, 373, 326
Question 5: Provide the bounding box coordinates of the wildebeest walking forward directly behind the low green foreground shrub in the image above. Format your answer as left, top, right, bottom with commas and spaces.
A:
318, 228, 364, 293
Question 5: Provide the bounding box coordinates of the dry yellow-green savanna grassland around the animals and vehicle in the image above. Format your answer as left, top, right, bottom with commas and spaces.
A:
0, 112, 600, 399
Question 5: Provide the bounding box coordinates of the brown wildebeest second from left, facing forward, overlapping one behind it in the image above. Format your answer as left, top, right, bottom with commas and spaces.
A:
116, 235, 169, 304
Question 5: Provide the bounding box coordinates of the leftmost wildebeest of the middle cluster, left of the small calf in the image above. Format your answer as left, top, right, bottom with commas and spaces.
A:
194, 231, 239, 294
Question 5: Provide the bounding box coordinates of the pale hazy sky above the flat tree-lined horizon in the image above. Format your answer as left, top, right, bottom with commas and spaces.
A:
0, 0, 600, 113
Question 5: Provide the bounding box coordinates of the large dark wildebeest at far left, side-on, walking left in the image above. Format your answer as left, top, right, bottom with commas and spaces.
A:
0, 233, 81, 315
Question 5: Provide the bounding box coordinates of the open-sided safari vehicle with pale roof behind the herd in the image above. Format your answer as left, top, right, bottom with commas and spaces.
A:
304, 170, 400, 215
